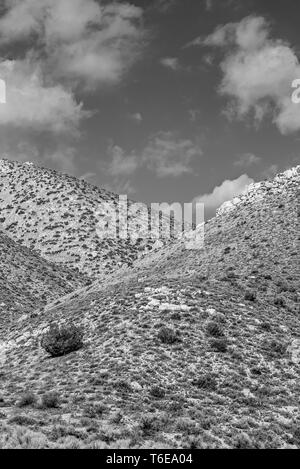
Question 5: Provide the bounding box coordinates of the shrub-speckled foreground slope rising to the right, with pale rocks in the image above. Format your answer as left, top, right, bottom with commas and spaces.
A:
0, 167, 300, 448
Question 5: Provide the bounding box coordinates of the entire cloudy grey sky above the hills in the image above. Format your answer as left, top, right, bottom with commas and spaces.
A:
0, 0, 300, 213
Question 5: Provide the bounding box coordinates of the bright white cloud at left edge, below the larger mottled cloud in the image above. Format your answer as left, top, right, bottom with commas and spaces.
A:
0, 60, 89, 134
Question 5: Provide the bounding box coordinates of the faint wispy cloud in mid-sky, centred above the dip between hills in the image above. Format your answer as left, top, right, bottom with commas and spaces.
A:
142, 132, 202, 177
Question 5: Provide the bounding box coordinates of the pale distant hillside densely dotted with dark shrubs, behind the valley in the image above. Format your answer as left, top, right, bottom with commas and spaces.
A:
0, 159, 168, 280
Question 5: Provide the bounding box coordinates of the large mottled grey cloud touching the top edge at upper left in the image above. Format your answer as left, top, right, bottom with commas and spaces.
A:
0, 0, 143, 88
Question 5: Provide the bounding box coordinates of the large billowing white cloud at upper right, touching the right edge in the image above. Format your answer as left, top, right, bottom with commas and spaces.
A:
202, 16, 300, 134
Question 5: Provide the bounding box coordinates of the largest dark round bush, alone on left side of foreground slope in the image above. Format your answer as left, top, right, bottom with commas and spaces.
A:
41, 324, 83, 357
